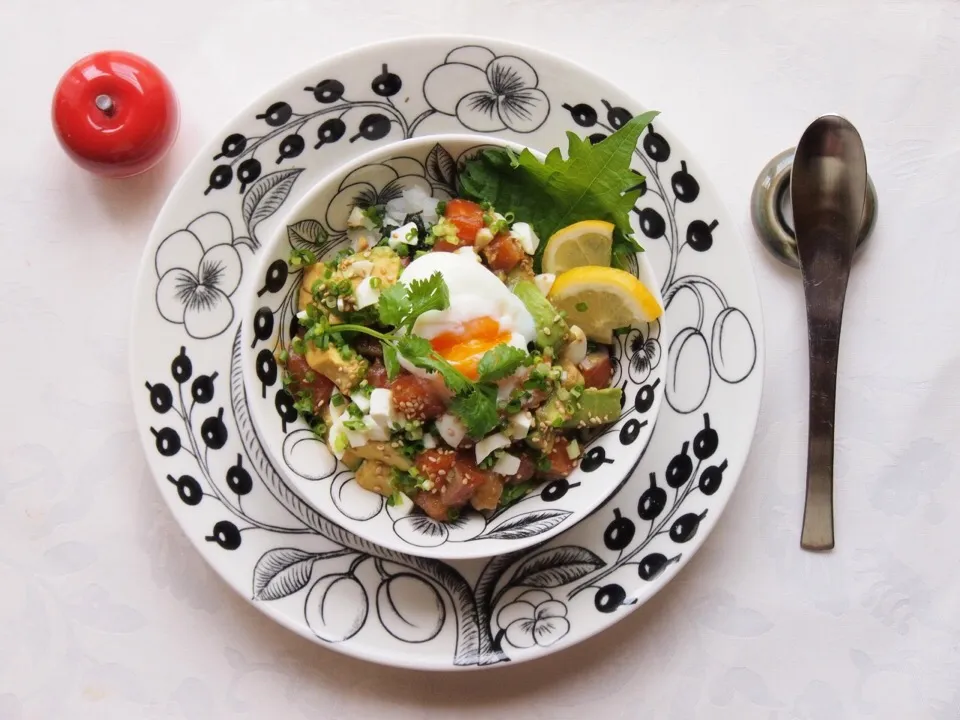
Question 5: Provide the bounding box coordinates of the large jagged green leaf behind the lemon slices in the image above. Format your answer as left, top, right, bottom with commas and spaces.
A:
460, 112, 658, 267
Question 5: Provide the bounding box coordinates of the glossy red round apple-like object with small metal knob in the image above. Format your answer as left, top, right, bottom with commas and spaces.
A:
52, 51, 180, 178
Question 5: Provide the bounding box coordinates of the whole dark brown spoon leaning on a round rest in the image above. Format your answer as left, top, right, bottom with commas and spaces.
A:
791, 115, 867, 550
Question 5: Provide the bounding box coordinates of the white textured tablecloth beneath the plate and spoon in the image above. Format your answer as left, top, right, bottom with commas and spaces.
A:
0, 0, 960, 720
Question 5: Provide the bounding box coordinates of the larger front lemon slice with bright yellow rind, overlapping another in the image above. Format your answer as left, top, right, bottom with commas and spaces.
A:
547, 266, 663, 344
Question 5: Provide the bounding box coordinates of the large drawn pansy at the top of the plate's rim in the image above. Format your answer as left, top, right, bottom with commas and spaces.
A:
423, 45, 550, 133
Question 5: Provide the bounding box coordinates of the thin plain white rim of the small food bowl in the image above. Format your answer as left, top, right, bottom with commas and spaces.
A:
240, 133, 670, 561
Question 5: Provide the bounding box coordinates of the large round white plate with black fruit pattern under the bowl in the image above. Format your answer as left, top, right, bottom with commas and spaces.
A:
131, 38, 763, 669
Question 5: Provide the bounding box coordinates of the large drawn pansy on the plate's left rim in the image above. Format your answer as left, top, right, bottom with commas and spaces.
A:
155, 212, 243, 340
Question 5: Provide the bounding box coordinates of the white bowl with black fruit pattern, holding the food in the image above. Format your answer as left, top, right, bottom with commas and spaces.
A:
241, 135, 668, 559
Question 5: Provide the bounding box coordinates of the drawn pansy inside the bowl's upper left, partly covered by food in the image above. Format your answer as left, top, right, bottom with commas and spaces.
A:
326, 157, 434, 232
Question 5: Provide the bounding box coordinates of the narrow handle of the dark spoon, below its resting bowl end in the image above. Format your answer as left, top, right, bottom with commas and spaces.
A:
800, 264, 847, 550
